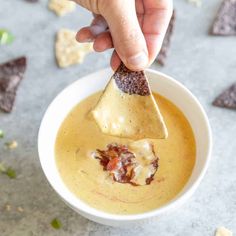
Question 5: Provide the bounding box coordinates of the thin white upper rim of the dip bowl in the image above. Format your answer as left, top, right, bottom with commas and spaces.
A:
38, 68, 212, 222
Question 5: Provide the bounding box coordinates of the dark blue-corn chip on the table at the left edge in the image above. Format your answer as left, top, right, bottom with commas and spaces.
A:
0, 57, 26, 112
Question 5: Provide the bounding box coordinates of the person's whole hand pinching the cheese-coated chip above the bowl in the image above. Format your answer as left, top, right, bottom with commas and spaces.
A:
74, 0, 173, 70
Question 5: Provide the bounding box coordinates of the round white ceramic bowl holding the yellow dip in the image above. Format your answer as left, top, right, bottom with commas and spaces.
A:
38, 69, 212, 226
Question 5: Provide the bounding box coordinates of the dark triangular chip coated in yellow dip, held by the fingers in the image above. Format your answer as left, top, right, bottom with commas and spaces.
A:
92, 64, 168, 140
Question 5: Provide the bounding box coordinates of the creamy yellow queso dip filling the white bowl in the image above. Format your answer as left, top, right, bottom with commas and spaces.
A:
55, 92, 196, 214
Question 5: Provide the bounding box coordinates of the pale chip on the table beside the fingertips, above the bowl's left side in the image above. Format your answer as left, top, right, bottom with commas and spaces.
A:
55, 29, 93, 68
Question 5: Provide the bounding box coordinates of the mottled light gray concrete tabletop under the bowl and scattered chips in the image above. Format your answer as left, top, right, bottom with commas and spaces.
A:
0, 0, 236, 236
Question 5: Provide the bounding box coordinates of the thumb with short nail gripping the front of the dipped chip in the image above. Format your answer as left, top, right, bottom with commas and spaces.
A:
101, 0, 149, 70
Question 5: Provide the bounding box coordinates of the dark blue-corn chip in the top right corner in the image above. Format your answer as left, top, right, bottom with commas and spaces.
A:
211, 0, 236, 36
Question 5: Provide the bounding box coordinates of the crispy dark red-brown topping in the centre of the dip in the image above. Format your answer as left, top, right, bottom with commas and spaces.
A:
95, 143, 158, 186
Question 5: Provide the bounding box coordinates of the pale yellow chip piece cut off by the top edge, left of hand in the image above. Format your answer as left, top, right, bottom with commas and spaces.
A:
48, 0, 76, 16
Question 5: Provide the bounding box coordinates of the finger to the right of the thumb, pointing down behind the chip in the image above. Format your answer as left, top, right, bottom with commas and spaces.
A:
142, 0, 173, 64
